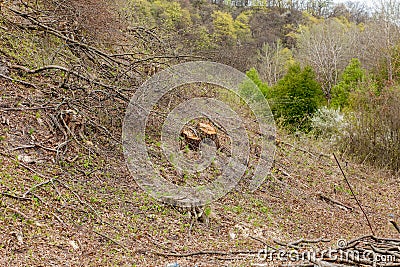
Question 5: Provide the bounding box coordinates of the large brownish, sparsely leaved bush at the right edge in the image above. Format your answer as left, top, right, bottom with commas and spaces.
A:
341, 86, 400, 171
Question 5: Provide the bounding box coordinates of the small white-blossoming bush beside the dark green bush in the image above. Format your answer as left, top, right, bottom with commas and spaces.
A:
311, 107, 346, 141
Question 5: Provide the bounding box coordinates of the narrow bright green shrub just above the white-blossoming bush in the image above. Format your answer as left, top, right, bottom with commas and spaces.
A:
331, 58, 365, 109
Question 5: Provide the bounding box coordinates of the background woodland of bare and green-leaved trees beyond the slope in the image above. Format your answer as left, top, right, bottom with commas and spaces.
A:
122, 0, 400, 171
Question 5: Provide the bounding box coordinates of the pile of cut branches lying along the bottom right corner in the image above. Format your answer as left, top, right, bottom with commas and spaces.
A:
154, 235, 400, 267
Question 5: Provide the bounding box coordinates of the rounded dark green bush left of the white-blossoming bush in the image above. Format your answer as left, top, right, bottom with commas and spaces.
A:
272, 64, 323, 131
